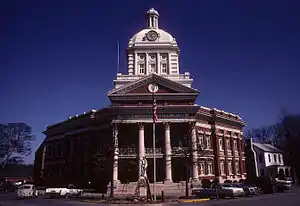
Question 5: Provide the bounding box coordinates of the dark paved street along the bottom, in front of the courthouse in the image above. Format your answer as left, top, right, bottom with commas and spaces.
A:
0, 188, 300, 206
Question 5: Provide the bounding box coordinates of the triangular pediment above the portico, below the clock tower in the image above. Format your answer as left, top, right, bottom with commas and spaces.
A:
107, 74, 199, 96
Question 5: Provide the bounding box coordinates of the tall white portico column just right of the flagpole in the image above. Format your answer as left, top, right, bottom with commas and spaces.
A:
164, 122, 173, 183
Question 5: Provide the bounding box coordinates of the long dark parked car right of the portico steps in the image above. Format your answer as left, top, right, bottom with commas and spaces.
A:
192, 184, 245, 198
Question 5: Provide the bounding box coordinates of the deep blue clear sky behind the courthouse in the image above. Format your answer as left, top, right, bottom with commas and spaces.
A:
0, 0, 300, 162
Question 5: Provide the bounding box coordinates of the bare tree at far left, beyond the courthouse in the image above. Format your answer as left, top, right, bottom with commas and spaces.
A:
0, 123, 35, 168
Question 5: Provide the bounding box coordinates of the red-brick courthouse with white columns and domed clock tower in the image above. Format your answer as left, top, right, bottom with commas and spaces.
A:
35, 9, 246, 192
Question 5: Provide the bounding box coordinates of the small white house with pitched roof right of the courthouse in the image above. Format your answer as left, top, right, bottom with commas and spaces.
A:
246, 139, 291, 177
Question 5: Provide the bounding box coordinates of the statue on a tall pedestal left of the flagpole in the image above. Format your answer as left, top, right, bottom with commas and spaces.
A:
134, 157, 152, 201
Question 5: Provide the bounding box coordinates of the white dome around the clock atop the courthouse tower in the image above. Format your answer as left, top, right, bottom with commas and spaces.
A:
128, 28, 177, 47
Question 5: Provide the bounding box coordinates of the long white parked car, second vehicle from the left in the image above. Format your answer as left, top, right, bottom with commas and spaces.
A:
45, 184, 83, 198
